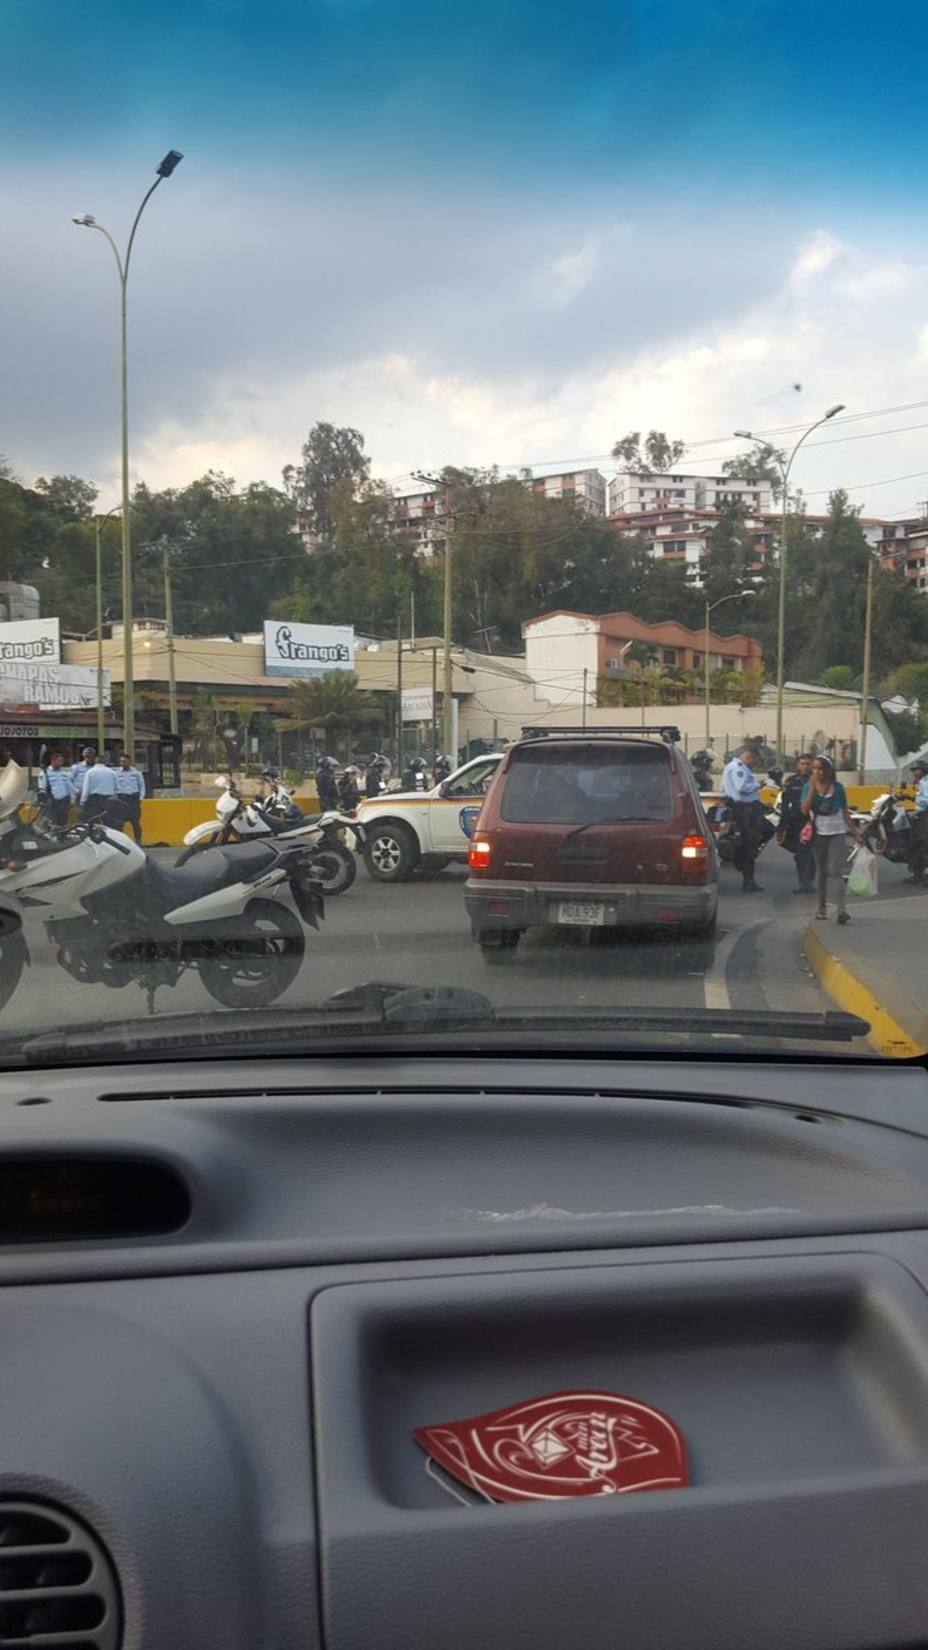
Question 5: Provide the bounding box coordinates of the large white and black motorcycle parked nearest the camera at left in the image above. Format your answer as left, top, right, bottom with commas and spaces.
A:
0, 762, 324, 1008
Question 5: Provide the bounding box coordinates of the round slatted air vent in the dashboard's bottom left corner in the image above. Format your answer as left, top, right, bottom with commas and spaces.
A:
0, 1498, 122, 1650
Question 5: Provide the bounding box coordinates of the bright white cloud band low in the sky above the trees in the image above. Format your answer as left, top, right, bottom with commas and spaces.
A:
126, 221, 928, 513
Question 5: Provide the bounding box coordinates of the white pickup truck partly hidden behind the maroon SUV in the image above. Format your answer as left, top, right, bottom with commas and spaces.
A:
357, 751, 502, 883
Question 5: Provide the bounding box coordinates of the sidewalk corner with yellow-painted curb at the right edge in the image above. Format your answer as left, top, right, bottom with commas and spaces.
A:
804, 888, 928, 1059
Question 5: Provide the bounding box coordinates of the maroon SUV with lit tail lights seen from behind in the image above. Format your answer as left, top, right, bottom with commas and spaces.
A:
464, 733, 718, 962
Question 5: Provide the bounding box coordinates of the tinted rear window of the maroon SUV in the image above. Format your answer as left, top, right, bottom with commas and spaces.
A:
500, 744, 674, 825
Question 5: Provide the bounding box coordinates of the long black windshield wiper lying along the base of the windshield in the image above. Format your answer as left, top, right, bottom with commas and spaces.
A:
0, 982, 870, 1066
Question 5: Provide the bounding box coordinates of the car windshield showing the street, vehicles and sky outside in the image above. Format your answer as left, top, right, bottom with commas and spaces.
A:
0, 0, 928, 1066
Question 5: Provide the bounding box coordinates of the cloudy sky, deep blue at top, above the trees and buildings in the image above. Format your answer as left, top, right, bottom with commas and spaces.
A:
0, 0, 928, 515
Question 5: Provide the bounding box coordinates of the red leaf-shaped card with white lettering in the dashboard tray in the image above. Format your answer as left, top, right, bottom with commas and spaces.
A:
413, 1393, 689, 1502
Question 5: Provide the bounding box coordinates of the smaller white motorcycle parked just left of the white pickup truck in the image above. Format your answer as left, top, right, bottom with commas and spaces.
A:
177, 776, 365, 898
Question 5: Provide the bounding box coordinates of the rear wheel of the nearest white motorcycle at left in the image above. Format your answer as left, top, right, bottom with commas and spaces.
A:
200, 899, 305, 1008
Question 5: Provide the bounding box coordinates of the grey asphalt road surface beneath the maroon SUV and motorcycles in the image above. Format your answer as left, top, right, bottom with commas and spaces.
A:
0, 843, 910, 1051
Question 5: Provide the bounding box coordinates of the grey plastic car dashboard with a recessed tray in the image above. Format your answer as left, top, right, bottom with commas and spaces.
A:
0, 1054, 928, 1650
